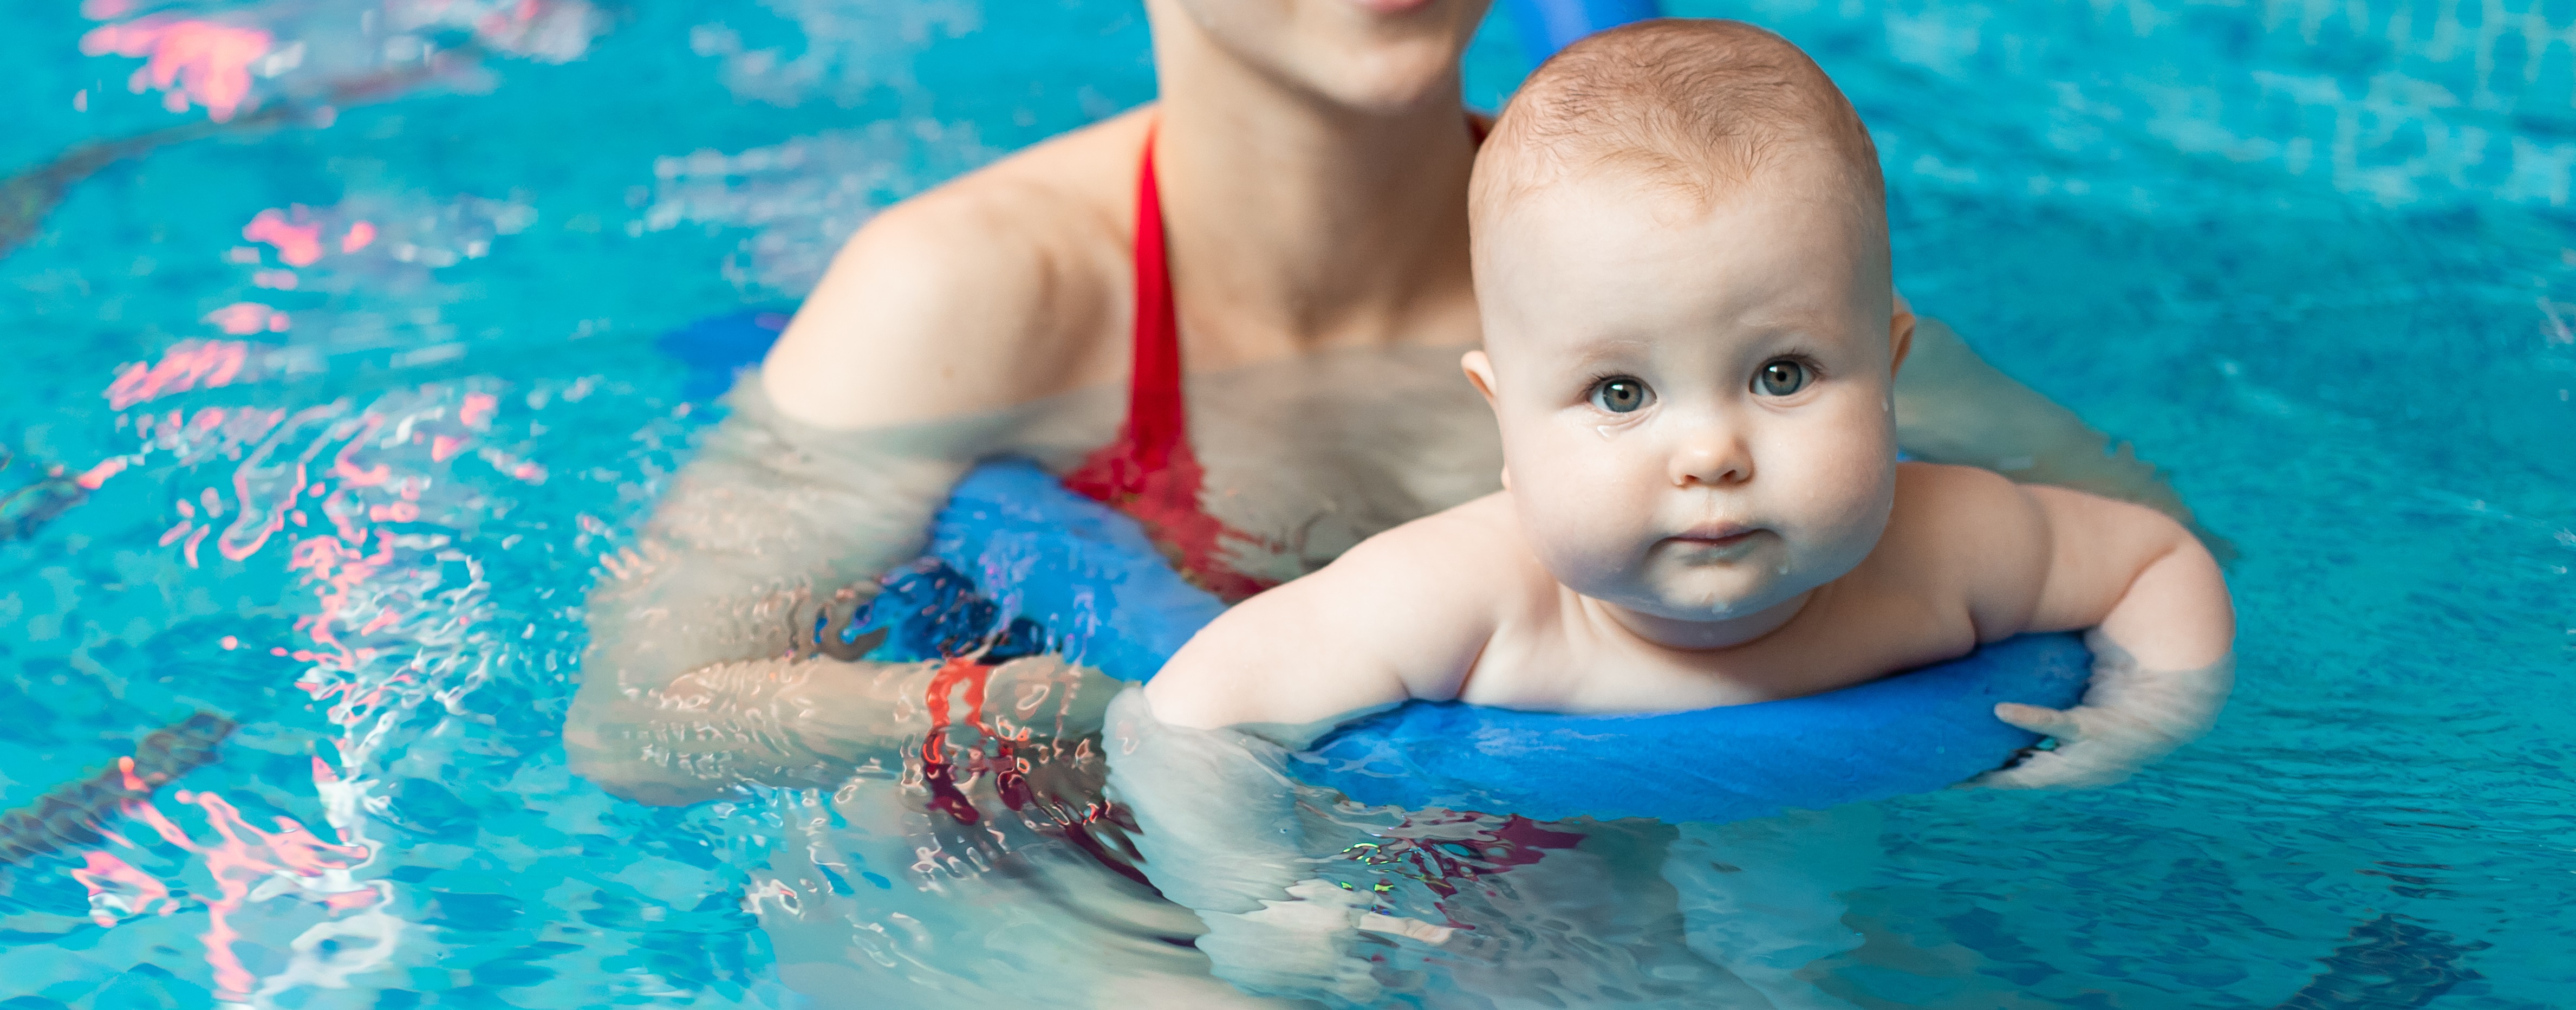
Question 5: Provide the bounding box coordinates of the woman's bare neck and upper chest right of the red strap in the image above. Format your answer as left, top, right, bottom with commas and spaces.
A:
1154, 28, 1476, 368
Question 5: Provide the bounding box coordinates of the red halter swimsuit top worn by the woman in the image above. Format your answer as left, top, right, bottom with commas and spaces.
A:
1064, 134, 1275, 603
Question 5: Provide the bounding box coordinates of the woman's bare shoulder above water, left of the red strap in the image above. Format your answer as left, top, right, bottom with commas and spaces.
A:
763, 111, 1146, 428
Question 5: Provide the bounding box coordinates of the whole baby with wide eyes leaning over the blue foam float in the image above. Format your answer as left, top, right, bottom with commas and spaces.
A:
1118, 21, 2233, 1010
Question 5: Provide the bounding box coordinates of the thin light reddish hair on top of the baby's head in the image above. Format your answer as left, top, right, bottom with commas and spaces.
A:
1471, 18, 1885, 226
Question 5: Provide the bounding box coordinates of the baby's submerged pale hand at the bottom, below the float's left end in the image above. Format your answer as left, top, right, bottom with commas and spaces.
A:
1198, 878, 1453, 1005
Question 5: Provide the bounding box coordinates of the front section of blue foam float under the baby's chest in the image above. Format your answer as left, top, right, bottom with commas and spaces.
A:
1301, 634, 2092, 822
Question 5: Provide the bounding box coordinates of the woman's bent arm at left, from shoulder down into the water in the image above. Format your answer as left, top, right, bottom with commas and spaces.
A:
564, 178, 1115, 804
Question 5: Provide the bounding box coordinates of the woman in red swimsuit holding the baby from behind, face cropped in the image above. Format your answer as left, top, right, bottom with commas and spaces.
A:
564, 0, 2205, 1005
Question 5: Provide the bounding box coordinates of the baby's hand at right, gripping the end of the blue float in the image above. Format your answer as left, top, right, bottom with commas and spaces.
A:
1968, 631, 2236, 788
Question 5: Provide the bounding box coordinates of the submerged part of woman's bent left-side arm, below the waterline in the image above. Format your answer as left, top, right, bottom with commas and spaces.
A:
564, 389, 966, 804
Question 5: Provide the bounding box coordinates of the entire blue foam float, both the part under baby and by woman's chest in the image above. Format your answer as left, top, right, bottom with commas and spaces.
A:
848, 464, 2089, 822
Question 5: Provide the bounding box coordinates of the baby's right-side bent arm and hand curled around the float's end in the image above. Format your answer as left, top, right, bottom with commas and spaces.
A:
1947, 474, 2236, 788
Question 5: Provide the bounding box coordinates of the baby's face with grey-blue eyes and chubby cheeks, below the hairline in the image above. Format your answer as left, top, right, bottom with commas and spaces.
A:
1468, 165, 1911, 636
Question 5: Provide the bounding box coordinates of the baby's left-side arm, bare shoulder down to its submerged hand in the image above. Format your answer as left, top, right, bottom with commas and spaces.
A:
1110, 520, 1492, 1002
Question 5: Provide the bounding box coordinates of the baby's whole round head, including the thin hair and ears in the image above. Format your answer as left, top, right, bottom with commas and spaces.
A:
1466, 21, 1914, 639
